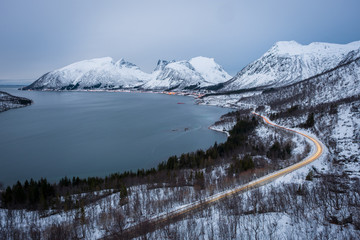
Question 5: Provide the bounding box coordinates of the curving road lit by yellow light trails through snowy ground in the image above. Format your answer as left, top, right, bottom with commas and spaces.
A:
109, 112, 324, 240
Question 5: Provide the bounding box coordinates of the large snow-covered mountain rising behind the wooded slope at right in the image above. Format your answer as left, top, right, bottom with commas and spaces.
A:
221, 41, 360, 91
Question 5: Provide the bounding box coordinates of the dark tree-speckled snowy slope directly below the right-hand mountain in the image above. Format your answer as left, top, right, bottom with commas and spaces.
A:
239, 50, 360, 108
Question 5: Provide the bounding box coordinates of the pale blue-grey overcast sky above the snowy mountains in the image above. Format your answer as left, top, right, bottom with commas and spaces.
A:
0, 0, 360, 80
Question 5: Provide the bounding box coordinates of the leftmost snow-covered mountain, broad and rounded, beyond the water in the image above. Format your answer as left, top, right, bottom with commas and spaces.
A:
23, 57, 151, 90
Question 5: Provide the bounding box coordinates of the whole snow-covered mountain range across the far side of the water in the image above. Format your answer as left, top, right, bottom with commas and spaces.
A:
23, 41, 360, 94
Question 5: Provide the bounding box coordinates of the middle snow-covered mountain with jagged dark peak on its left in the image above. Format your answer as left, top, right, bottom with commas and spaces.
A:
142, 57, 231, 90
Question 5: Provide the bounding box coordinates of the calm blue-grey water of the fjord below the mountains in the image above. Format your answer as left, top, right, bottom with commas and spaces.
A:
0, 87, 229, 185
